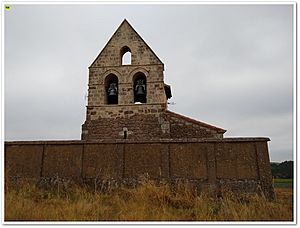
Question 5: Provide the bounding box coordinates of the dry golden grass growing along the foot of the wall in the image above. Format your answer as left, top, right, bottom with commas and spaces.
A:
5, 181, 293, 221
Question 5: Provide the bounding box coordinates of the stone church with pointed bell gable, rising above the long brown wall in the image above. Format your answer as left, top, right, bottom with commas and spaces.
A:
81, 20, 226, 141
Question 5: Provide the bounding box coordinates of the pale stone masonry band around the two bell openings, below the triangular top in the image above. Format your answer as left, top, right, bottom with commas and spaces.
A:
88, 65, 166, 106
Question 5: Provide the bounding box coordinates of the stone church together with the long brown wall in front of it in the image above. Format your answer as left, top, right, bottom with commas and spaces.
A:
5, 20, 274, 199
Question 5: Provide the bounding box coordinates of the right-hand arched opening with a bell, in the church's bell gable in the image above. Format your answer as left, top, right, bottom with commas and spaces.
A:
133, 72, 147, 103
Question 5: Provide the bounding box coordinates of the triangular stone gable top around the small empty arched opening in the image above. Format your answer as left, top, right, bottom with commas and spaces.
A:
90, 19, 163, 67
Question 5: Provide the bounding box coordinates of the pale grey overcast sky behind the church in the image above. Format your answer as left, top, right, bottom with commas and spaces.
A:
4, 5, 293, 161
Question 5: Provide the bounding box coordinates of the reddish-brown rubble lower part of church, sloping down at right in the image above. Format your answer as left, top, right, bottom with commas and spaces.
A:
82, 111, 225, 141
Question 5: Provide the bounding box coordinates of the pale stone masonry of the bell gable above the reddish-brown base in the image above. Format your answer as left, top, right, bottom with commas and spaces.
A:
86, 20, 167, 122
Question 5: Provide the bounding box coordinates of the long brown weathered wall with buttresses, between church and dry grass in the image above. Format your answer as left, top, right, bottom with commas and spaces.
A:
5, 138, 274, 197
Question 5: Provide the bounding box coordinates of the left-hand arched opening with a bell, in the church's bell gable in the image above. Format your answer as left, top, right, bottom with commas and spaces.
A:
105, 74, 119, 104
